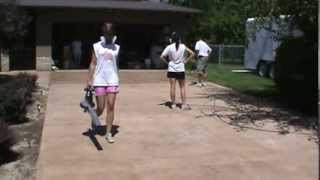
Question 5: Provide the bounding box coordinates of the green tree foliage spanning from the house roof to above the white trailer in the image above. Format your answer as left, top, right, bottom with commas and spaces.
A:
169, 0, 318, 44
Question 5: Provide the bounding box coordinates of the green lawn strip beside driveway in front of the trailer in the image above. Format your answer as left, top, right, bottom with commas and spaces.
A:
208, 64, 278, 96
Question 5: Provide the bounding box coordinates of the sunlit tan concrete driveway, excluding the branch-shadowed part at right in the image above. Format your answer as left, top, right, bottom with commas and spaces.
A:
38, 71, 318, 180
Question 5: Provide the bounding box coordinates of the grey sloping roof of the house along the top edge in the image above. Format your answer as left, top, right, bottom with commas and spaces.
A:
17, 0, 200, 13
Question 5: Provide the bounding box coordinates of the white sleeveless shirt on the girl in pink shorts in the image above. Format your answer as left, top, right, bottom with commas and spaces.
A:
93, 39, 120, 86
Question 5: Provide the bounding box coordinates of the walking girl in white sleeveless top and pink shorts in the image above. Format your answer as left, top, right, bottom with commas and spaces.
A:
87, 22, 120, 143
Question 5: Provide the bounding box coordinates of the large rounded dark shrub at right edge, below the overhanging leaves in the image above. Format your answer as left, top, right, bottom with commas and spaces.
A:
275, 38, 318, 113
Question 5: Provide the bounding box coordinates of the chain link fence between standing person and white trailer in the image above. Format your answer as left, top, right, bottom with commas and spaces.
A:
210, 44, 245, 65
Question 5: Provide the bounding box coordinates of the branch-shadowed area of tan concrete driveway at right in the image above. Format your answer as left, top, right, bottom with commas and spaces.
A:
201, 86, 319, 142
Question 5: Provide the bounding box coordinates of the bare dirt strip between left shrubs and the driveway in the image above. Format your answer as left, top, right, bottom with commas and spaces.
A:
0, 83, 48, 180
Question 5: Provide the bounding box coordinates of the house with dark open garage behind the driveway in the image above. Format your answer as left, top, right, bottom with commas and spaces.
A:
1, 0, 200, 70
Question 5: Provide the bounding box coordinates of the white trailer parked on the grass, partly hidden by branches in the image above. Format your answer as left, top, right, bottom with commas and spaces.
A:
244, 16, 303, 78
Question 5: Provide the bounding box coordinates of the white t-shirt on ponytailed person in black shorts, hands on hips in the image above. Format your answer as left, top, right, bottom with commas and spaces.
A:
161, 43, 186, 72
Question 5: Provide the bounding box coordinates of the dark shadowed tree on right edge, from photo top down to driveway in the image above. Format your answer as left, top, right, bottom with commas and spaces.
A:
273, 0, 318, 114
